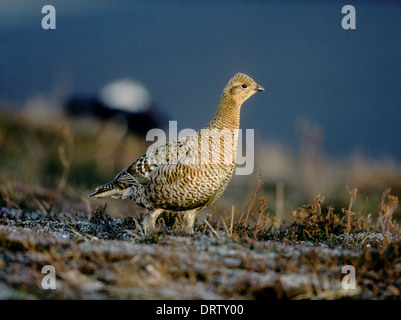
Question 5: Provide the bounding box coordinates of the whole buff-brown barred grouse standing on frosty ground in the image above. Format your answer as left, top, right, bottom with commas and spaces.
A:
89, 73, 264, 234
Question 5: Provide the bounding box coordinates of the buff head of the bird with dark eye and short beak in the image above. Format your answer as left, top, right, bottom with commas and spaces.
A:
224, 73, 265, 105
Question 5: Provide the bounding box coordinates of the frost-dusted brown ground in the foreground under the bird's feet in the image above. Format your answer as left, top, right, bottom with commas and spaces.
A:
0, 198, 401, 299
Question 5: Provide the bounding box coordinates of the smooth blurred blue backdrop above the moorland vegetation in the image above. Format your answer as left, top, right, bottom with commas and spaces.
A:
0, 0, 401, 161
